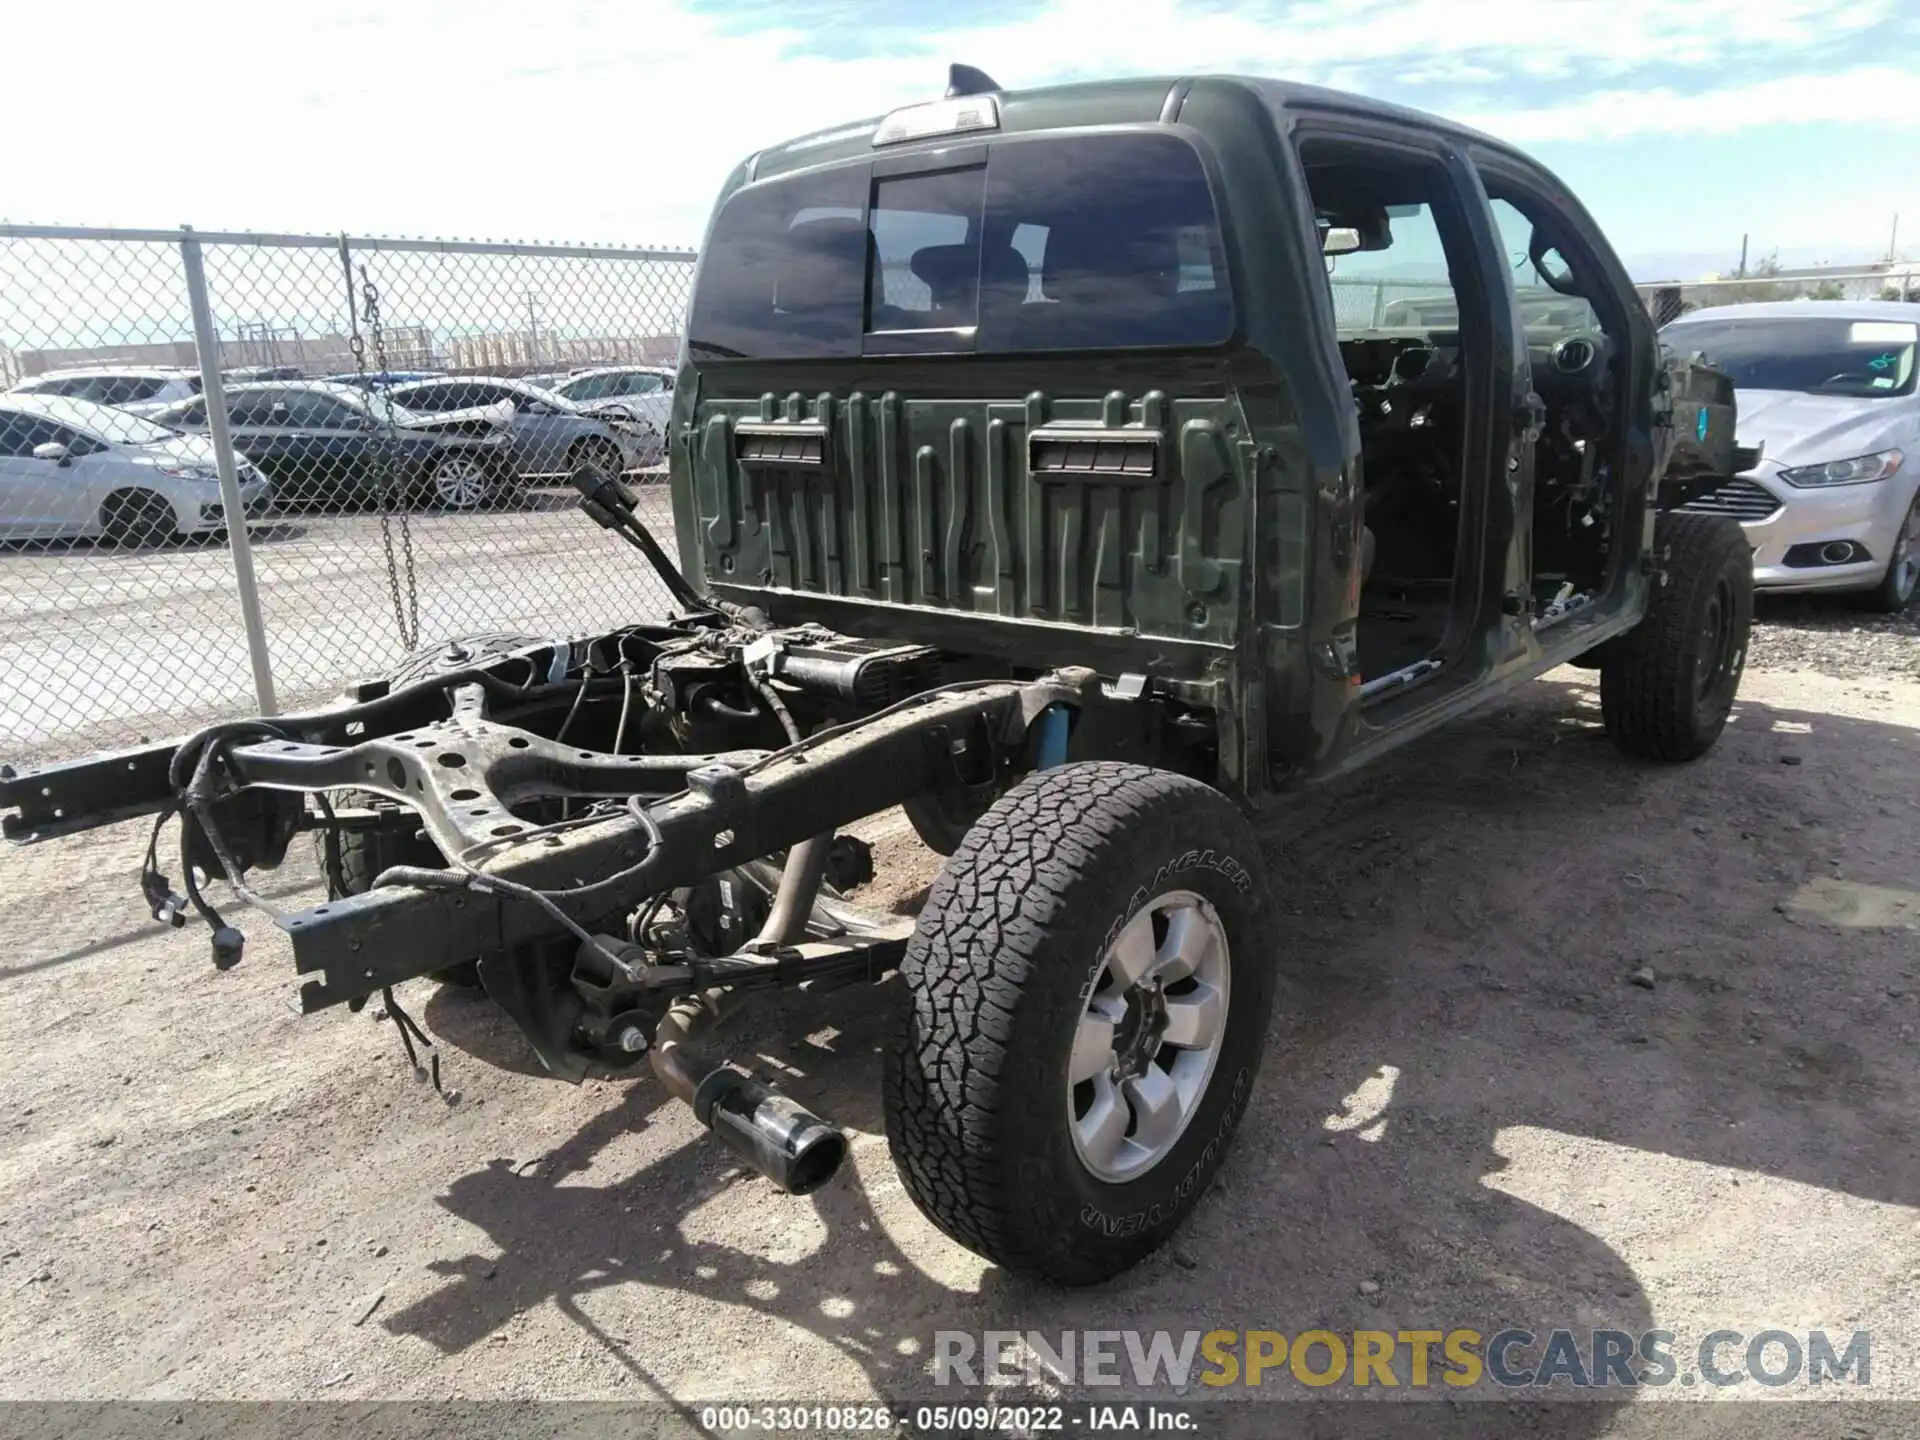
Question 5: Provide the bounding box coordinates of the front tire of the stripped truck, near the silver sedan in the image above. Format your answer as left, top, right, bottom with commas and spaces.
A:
1599, 513, 1753, 760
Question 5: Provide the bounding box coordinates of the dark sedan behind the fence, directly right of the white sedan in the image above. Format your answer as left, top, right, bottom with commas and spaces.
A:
154, 380, 515, 511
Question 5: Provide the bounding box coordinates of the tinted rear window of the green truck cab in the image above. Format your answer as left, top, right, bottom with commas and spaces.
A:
687, 134, 1233, 359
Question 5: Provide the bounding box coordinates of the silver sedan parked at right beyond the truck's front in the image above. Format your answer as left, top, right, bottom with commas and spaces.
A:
1661, 300, 1920, 612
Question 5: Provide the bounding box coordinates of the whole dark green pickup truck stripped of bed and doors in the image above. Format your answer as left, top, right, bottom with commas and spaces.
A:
0, 65, 1751, 1284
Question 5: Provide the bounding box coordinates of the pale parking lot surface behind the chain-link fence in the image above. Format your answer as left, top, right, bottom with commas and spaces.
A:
0, 484, 672, 760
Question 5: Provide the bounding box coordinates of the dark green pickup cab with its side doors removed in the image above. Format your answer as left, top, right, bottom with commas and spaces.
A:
670, 67, 1732, 797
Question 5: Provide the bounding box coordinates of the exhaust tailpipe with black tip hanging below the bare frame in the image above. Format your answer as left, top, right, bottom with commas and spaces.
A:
647, 998, 847, 1194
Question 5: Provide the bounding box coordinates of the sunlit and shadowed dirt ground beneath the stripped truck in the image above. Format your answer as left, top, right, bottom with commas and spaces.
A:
0, 639, 1920, 1436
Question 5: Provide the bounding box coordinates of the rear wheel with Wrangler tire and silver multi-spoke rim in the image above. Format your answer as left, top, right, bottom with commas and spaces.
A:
885, 762, 1275, 1284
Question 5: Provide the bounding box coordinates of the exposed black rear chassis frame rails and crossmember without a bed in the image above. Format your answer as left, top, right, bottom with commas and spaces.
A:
0, 618, 1125, 1077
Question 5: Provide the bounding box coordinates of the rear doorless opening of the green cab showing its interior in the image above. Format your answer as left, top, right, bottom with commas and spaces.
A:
1302, 140, 1476, 682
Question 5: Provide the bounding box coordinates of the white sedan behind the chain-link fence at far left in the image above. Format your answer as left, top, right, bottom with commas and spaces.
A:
0, 392, 273, 545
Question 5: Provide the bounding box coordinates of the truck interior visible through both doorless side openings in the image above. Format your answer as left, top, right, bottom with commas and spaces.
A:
1302, 140, 1622, 684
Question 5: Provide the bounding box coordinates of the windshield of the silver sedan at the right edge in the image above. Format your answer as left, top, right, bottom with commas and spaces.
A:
1661, 315, 1920, 399
